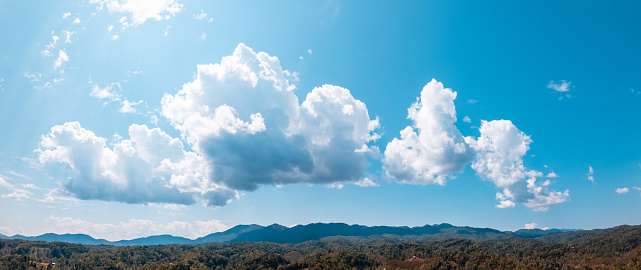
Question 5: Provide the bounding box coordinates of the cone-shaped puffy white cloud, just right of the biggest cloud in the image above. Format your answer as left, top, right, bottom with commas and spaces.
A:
383, 79, 474, 185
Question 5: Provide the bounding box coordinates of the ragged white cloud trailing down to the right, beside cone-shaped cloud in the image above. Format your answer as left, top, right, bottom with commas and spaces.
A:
465, 120, 570, 211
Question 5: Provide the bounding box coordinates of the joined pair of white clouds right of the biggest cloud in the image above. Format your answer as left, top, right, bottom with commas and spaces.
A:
383, 79, 569, 211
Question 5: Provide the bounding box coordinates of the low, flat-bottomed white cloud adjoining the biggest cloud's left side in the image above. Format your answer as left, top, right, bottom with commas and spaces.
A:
36, 122, 238, 206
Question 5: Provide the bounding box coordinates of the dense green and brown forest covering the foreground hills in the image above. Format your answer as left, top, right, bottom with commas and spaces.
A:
0, 226, 641, 270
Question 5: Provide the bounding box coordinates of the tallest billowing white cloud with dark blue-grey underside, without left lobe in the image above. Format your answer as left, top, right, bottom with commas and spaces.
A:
162, 44, 378, 190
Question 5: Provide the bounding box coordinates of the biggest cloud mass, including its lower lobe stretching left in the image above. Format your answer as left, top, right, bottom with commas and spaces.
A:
37, 44, 379, 206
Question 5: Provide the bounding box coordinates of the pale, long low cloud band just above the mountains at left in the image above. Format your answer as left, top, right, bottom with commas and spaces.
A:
44, 216, 229, 241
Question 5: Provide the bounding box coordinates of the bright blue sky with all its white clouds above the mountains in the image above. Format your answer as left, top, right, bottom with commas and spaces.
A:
0, 0, 641, 240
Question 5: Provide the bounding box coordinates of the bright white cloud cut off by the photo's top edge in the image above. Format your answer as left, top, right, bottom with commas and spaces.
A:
89, 0, 183, 28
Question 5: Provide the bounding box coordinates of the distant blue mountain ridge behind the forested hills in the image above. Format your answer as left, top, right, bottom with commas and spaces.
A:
0, 223, 575, 246
